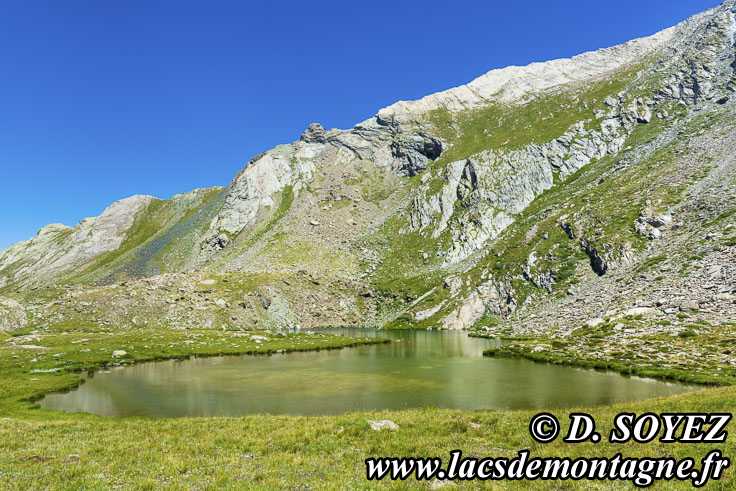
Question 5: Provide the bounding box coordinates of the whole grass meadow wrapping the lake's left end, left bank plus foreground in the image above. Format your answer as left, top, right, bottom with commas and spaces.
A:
0, 329, 736, 489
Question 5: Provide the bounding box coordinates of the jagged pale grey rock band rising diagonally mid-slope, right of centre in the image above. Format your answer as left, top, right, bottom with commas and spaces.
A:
407, 111, 628, 264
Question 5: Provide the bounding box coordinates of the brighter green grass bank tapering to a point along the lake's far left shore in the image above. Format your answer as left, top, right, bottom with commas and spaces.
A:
0, 329, 389, 417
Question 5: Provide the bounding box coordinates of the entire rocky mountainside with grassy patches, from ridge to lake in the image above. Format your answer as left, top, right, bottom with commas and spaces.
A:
0, 0, 736, 376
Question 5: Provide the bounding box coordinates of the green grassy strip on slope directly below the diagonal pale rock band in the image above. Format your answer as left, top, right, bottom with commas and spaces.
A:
448, 108, 713, 312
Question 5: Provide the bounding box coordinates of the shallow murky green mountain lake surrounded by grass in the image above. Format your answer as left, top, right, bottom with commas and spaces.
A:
40, 329, 697, 417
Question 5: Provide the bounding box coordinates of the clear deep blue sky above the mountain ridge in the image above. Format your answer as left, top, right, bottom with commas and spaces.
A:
0, 0, 719, 249
